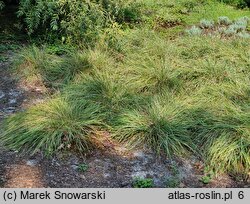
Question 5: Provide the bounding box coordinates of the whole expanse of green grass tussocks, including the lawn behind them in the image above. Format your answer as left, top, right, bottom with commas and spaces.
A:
0, 0, 250, 180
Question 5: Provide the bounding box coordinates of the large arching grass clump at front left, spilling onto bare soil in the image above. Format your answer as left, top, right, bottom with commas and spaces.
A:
1, 97, 102, 155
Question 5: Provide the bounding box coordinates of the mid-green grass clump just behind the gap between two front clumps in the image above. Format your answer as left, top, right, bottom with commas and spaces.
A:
64, 71, 137, 111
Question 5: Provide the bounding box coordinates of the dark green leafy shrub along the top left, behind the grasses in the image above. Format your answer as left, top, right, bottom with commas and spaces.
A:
18, 0, 142, 45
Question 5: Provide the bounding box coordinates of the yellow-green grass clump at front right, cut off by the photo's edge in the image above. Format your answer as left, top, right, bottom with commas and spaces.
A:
189, 90, 250, 175
